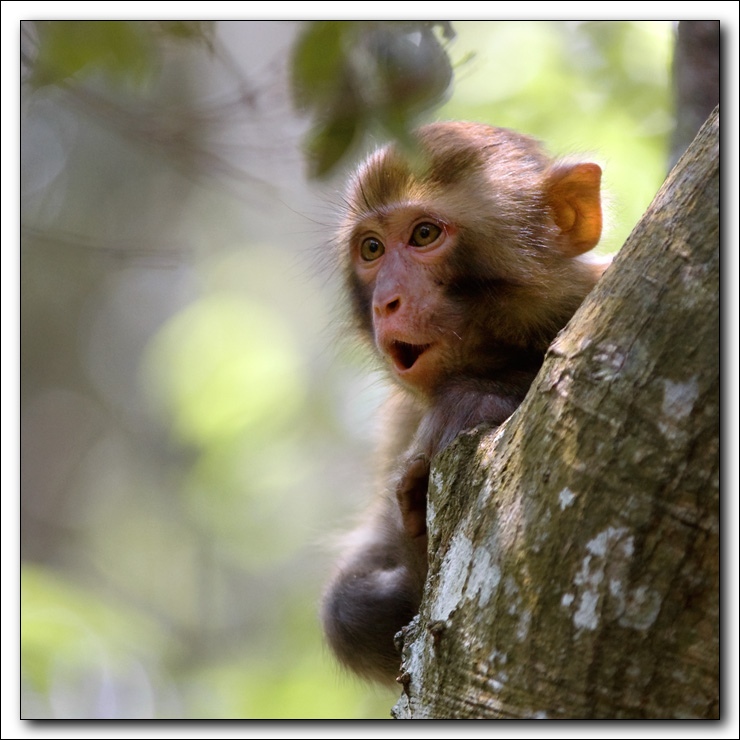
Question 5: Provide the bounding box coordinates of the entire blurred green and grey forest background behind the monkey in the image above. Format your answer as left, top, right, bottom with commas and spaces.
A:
20, 21, 675, 719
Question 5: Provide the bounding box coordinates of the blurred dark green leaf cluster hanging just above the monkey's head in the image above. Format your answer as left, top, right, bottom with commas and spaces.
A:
292, 21, 454, 177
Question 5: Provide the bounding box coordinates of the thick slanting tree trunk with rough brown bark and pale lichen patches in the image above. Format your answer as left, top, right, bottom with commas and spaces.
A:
393, 109, 719, 719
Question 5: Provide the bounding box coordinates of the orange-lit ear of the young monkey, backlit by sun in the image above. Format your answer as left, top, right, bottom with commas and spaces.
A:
546, 163, 601, 257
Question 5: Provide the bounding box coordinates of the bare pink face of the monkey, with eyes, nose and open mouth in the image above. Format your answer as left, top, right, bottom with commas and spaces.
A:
350, 205, 462, 394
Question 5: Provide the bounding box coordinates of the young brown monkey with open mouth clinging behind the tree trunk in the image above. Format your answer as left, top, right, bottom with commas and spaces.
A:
321, 122, 609, 684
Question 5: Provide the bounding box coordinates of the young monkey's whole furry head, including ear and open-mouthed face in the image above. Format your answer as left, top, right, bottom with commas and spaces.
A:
337, 123, 601, 399
